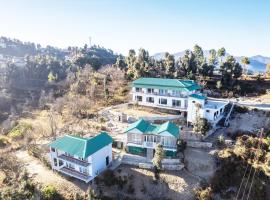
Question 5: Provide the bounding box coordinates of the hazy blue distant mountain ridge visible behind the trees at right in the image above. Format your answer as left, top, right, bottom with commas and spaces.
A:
152, 50, 270, 72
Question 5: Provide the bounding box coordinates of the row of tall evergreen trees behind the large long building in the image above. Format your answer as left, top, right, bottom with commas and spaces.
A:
114, 44, 244, 88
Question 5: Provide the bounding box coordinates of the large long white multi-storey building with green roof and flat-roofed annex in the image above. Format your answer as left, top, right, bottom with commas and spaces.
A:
132, 78, 229, 126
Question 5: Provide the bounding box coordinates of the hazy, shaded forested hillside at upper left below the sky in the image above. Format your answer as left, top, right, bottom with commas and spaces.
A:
0, 37, 117, 121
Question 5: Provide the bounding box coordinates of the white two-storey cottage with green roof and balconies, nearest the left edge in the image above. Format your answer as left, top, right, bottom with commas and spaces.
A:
49, 132, 113, 183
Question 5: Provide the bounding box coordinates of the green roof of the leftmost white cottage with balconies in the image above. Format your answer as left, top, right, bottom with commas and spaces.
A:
49, 132, 113, 158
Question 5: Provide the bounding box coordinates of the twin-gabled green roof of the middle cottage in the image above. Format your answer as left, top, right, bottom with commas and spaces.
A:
125, 119, 179, 138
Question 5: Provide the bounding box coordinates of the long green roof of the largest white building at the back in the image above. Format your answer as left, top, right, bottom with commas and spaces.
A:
133, 78, 201, 91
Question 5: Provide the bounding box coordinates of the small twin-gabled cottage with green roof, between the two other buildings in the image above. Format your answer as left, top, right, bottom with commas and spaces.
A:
125, 119, 180, 158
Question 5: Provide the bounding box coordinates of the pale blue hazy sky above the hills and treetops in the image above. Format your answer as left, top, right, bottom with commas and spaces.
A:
0, 0, 270, 56
